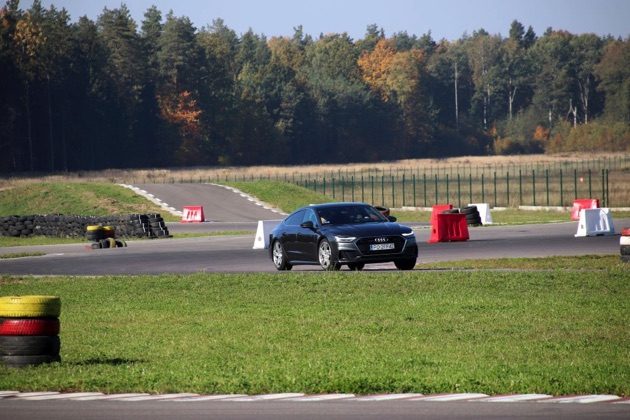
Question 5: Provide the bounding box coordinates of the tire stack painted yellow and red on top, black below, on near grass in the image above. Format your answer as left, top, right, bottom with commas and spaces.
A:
0, 296, 61, 367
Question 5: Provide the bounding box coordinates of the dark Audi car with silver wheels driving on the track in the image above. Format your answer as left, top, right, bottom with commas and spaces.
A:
269, 203, 418, 270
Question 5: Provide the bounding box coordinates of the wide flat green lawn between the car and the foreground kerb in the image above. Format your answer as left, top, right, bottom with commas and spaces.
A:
0, 259, 630, 395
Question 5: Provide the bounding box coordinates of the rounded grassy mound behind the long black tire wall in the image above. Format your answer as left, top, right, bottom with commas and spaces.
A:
0, 182, 175, 220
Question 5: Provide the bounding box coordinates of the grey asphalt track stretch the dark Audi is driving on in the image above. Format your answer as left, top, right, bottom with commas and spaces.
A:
0, 219, 630, 275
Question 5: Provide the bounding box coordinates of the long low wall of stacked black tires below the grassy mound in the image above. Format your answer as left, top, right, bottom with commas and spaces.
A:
0, 213, 169, 242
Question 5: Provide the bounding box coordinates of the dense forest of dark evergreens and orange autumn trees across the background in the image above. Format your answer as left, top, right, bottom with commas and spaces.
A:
0, 0, 630, 173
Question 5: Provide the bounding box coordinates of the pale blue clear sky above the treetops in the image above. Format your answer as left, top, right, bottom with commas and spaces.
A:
20, 0, 630, 40
